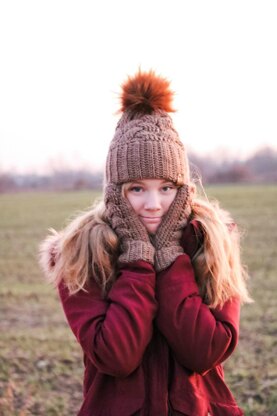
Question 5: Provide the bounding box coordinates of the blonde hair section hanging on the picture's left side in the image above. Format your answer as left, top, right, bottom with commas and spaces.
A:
50, 201, 119, 295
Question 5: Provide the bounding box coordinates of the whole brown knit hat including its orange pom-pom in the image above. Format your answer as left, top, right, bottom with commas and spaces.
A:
106, 70, 189, 185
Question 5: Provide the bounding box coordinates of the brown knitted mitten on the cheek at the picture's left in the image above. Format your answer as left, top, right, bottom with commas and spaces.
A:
105, 183, 155, 264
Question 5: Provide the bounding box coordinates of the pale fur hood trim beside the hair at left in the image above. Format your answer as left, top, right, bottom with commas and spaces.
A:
39, 228, 62, 282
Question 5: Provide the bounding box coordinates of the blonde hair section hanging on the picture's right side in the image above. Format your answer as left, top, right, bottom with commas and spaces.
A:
192, 199, 252, 308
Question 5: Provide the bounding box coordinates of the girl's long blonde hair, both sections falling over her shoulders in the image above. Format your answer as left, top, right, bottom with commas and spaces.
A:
48, 184, 252, 308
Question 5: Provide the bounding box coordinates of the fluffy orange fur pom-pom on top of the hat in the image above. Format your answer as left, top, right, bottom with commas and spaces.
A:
120, 70, 175, 114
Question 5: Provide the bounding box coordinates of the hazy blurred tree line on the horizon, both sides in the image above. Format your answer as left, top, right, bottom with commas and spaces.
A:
0, 147, 277, 193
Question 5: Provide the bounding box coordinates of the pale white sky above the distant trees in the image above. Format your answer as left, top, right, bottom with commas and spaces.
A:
0, 0, 277, 172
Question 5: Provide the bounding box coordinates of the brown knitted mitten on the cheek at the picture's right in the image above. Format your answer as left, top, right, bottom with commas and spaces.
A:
153, 185, 191, 272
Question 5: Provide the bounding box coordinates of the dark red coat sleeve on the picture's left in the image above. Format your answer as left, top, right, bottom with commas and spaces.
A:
59, 260, 157, 377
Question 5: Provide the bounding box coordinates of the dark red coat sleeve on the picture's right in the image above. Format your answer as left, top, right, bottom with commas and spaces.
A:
156, 254, 240, 374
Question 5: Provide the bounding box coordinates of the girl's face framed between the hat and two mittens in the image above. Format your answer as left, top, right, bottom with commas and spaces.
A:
125, 179, 178, 234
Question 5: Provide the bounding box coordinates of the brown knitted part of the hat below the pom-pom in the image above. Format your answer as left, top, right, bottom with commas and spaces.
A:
106, 110, 189, 185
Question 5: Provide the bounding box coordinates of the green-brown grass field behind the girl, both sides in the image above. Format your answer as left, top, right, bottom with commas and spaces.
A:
0, 186, 277, 416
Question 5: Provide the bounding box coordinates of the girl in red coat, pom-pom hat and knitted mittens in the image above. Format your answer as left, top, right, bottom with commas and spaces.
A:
41, 71, 250, 416
